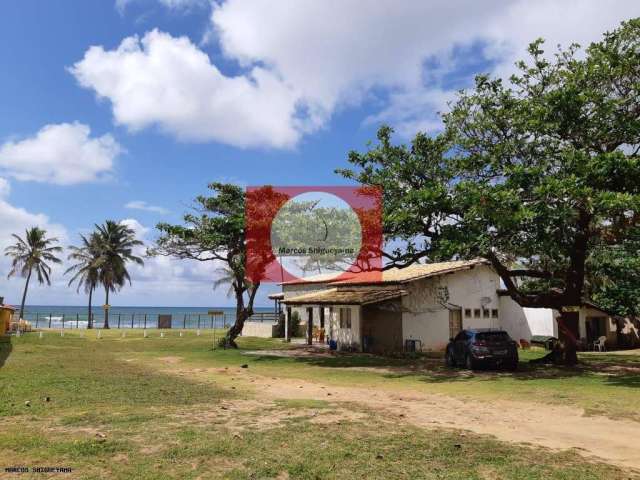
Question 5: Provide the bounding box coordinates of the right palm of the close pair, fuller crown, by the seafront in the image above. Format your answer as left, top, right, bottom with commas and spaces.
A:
96, 220, 144, 328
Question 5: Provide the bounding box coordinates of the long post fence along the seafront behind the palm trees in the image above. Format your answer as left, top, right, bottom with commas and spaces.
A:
24, 312, 278, 329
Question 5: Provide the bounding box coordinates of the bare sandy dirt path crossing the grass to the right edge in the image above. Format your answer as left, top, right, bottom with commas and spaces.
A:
251, 376, 640, 471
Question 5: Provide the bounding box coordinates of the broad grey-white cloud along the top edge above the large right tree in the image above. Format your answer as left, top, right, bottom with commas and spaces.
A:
212, 0, 640, 138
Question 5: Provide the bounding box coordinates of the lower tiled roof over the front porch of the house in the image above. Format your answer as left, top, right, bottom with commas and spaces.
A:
284, 288, 407, 305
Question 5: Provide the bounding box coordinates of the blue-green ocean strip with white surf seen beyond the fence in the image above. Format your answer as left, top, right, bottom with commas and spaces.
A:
18, 305, 274, 328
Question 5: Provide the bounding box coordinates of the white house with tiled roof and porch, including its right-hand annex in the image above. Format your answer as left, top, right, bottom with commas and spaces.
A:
273, 260, 628, 353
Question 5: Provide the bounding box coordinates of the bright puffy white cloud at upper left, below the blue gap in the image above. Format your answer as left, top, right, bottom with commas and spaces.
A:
71, 30, 299, 147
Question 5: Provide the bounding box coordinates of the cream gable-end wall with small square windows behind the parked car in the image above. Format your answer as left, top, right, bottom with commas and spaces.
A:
402, 265, 500, 350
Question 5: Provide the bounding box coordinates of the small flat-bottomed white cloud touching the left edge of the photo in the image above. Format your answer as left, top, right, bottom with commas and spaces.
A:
0, 123, 122, 185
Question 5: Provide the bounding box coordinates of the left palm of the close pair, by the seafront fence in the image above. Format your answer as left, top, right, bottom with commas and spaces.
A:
64, 232, 101, 328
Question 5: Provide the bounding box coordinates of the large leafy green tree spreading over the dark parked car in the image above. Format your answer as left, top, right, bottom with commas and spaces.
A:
339, 19, 640, 364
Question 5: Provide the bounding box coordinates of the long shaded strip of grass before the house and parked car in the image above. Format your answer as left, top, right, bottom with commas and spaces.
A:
245, 344, 640, 388
